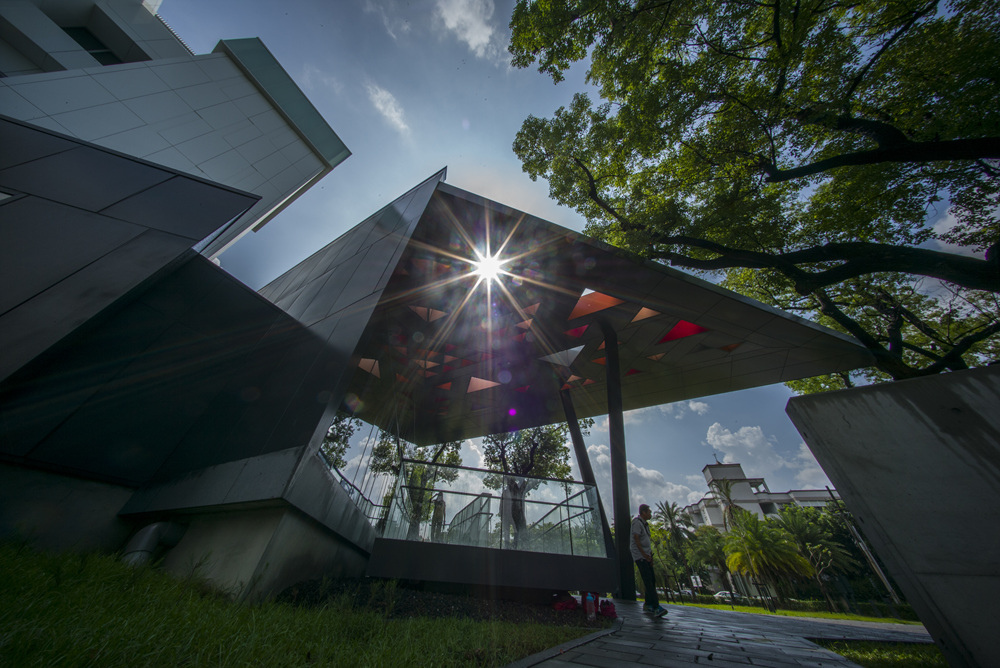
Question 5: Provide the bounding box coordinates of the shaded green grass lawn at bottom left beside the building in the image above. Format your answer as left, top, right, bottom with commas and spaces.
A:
0, 545, 593, 667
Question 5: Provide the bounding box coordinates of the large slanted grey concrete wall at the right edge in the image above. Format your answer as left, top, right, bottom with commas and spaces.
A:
786, 367, 1000, 666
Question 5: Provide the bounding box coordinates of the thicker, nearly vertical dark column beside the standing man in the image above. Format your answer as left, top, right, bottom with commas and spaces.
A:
601, 321, 635, 601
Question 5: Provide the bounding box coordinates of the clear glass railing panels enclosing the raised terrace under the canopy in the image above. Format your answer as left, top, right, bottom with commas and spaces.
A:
382, 460, 607, 557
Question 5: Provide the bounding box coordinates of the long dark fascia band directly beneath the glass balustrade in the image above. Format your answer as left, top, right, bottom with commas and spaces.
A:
367, 538, 617, 591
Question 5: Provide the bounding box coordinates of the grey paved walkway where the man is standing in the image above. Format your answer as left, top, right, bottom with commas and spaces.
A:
509, 601, 932, 668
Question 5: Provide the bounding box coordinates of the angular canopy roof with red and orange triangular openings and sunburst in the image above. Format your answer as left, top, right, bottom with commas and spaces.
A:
261, 170, 871, 444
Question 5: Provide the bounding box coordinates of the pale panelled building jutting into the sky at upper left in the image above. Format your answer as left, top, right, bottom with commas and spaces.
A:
0, 0, 350, 257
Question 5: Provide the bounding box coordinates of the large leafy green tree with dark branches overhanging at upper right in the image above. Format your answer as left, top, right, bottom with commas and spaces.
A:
510, 0, 1000, 389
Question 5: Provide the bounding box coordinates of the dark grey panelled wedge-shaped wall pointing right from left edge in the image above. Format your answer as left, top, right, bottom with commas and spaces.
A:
0, 117, 259, 379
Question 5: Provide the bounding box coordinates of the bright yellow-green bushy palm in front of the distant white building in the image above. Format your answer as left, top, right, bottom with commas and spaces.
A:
726, 512, 813, 600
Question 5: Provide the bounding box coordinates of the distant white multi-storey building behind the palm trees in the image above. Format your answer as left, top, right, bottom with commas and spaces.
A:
682, 464, 840, 531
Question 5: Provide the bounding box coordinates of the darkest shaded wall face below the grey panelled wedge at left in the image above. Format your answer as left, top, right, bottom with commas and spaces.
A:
0, 252, 328, 485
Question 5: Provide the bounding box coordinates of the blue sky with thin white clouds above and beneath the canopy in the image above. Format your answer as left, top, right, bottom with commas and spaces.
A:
159, 0, 829, 511
